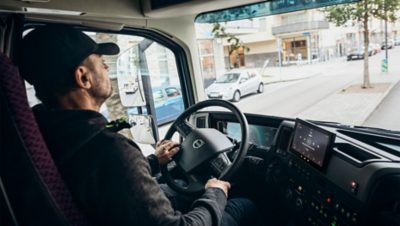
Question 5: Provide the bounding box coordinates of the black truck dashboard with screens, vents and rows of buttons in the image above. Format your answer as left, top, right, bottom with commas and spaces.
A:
193, 112, 400, 226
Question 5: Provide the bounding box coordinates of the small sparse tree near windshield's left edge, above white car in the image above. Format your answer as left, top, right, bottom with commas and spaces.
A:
212, 23, 250, 68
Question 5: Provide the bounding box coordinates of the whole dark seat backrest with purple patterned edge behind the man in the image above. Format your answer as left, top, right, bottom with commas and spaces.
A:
0, 53, 87, 225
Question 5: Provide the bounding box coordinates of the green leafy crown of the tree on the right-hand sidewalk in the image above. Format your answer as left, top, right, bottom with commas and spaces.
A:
324, 0, 400, 26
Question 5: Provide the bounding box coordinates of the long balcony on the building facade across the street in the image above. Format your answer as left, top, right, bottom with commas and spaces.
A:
272, 21, 329, 35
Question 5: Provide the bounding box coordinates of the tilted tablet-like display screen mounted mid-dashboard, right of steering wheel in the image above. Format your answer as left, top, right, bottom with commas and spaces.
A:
291, 119, 335, 167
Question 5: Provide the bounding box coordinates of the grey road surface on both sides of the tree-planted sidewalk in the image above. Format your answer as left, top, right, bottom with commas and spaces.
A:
235, 47, 400, 130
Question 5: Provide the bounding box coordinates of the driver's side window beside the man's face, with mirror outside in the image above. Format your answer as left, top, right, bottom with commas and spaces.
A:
24, 27, 185, 155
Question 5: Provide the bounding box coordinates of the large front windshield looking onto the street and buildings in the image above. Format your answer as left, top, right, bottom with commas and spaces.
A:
195, 1, 400, 131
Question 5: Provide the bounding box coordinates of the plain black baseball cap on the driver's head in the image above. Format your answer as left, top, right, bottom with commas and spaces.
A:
19, 25, 119, 85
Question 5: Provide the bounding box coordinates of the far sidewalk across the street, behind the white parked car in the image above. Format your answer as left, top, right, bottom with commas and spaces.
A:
260, 57, 346, 84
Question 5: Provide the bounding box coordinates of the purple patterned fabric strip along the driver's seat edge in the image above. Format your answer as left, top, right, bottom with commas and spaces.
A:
0, 53, 87, 225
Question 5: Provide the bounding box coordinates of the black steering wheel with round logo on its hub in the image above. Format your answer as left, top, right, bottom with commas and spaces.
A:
161, 99, 249, 194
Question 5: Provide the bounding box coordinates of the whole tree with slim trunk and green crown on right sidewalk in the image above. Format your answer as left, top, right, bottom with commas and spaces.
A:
324, 0, 400, 88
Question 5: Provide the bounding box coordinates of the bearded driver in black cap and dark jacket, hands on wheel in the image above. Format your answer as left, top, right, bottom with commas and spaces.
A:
20, 25, 254, 225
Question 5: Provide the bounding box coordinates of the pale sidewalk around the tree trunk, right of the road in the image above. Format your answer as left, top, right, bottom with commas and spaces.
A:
299, 68, 400, 125
